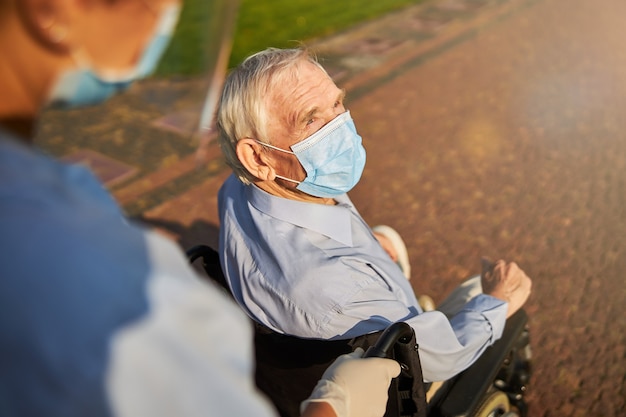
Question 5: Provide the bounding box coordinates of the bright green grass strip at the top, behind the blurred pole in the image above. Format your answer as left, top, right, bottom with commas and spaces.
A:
157, 0, 423, 76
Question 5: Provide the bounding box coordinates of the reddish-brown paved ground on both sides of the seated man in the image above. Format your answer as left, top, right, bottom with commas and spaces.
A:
40, 0, 626, 417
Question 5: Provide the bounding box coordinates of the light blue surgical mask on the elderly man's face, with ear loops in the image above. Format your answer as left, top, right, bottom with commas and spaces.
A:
257, 111, 365, 198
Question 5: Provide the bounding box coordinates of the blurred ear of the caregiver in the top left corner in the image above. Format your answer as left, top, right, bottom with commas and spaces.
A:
15, 0, 72, 54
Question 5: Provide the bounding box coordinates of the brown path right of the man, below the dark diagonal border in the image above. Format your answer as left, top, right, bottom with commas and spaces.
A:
350, 0, 626, 416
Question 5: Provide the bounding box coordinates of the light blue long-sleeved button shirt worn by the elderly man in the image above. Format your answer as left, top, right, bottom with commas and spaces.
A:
219, 176, 507, 381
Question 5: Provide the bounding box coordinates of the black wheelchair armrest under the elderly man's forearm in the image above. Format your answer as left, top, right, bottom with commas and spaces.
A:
434, 309, 528, 417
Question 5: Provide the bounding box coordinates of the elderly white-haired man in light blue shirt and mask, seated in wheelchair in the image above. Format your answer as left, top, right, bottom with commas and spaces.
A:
218, 48, 531, 381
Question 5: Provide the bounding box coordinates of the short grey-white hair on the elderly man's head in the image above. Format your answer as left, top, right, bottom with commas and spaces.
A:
217, 47, 325, 184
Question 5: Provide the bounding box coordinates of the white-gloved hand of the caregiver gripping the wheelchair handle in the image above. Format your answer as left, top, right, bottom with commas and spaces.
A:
300, 348, 400, 417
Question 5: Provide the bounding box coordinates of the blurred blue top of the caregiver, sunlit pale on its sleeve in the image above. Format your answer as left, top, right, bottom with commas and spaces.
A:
0, 131, 273, 417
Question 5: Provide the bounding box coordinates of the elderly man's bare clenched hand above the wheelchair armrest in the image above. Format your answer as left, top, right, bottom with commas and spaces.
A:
480, 258, 532, 318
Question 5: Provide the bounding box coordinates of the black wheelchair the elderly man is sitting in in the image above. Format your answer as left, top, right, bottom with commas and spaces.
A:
187, 245, 532, 417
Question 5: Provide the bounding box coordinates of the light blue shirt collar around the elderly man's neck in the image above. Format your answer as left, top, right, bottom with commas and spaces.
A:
246, 185, 352, 246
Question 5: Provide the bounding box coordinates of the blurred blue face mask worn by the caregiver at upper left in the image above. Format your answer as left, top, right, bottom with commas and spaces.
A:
48, 3, 180, 107
